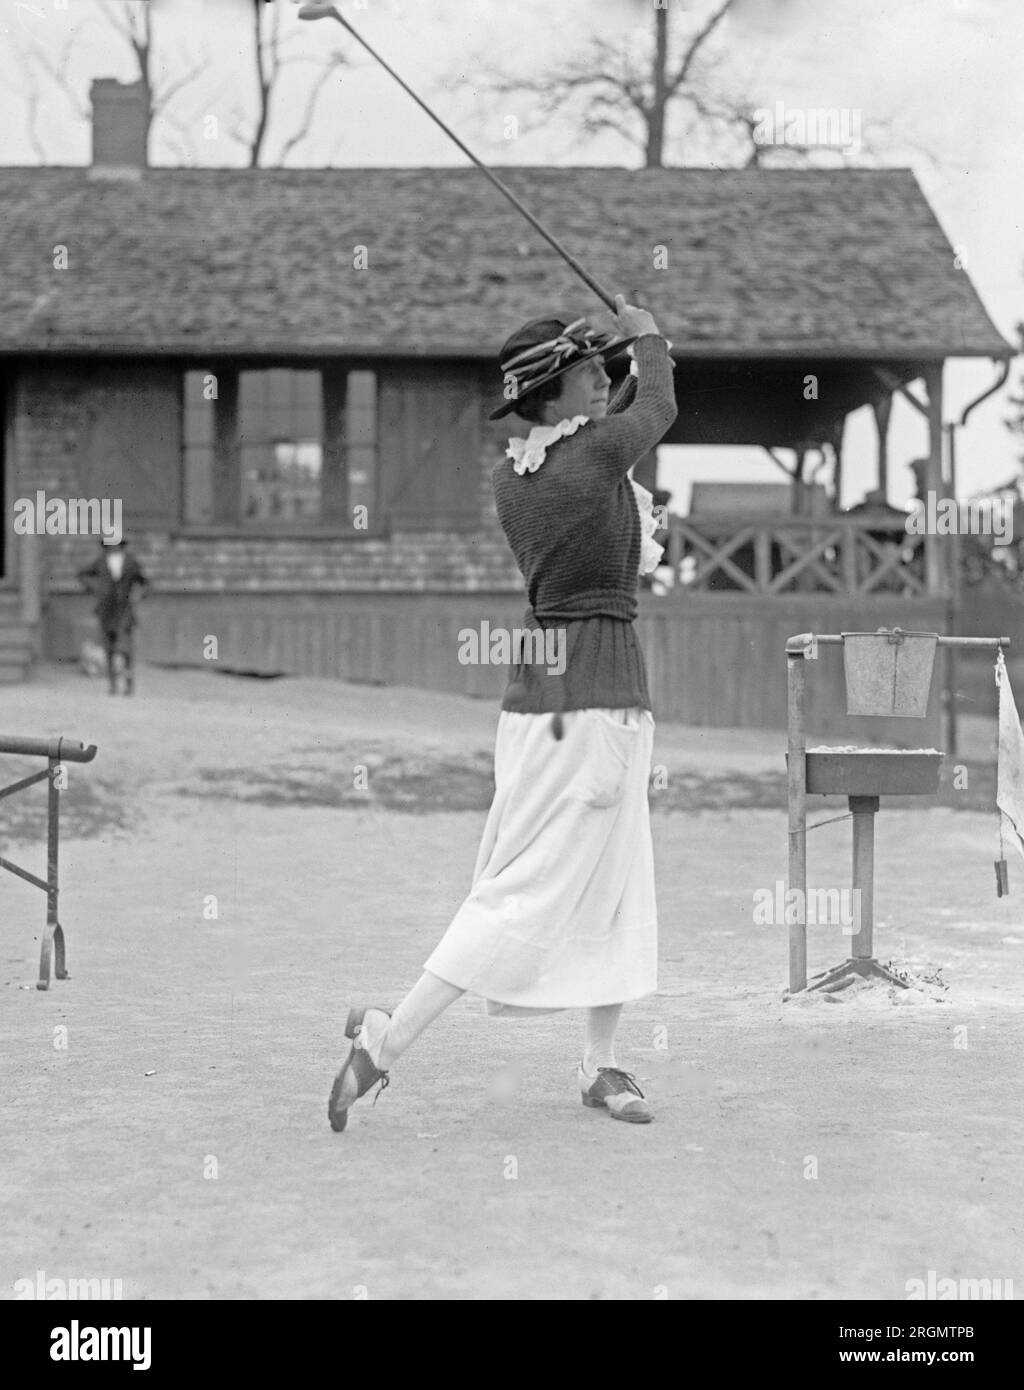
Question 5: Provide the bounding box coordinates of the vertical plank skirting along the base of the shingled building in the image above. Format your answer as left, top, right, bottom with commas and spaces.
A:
53, 591, 946, 746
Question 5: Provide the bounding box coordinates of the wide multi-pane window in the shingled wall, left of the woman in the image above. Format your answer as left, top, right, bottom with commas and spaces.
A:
183, 366, 378, 535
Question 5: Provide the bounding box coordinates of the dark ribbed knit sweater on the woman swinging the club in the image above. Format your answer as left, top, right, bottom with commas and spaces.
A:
492, 334, 677, 713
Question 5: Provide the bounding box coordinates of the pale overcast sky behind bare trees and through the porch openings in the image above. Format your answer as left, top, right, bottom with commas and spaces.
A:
0, 0, 1024, 503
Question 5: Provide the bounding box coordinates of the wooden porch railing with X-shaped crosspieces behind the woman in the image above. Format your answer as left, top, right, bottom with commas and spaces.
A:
666, 516, 927, 598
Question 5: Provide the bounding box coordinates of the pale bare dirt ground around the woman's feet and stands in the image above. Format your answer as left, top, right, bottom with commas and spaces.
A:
0, 667, 1024, 1300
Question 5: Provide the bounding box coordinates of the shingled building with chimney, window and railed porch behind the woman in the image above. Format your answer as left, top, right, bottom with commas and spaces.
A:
0, 82, 1013, 727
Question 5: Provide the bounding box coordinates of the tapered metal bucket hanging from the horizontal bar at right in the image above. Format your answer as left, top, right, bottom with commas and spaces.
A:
842, 627, 938, 719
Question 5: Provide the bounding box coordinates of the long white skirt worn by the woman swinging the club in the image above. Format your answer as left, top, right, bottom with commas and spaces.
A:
424, 709, 657, 1013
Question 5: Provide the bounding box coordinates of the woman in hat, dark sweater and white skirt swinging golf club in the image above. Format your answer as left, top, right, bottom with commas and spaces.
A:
328, 295, 675, 1130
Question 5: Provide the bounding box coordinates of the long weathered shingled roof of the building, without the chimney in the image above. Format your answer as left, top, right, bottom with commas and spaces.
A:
0, 168, 1013, 359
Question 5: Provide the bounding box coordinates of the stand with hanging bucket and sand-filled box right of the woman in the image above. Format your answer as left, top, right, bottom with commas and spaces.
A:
786, 628, 1010, 995
